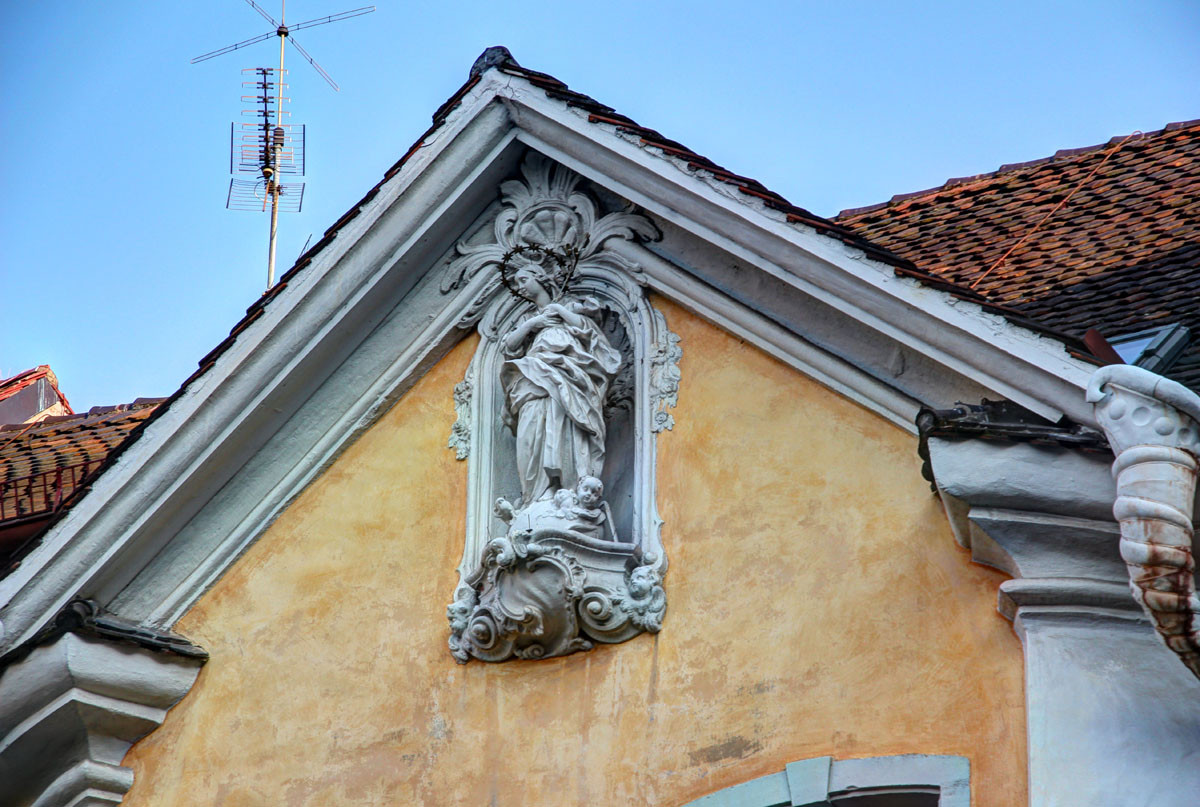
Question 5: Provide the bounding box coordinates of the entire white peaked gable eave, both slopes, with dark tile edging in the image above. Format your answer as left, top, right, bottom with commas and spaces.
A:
0, 49, 1092, 654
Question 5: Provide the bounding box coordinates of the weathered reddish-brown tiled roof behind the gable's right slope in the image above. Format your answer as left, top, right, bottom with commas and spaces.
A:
836, 120, 1200, 388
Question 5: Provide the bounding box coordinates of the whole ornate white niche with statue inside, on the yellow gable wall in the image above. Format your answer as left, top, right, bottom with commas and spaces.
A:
442, 151, 682, 663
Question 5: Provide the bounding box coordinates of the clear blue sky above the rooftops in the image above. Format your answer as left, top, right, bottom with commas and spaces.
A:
0, 0, 1200, 411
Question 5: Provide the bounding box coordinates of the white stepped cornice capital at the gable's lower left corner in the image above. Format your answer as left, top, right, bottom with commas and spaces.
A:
0, 633, 200, 807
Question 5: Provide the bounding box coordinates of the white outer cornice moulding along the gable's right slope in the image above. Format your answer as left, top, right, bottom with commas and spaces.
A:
494, 79, 1094, 423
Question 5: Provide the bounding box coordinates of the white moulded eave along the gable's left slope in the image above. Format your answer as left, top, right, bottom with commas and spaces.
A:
0, 74, 520, 657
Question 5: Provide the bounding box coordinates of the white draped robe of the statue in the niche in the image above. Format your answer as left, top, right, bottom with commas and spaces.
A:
500, 300, 620, 504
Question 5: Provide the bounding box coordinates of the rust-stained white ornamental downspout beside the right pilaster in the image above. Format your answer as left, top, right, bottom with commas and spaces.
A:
1087, 364, 1200, 679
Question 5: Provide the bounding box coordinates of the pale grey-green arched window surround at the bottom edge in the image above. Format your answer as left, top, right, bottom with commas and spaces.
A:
683, 754, 971, 807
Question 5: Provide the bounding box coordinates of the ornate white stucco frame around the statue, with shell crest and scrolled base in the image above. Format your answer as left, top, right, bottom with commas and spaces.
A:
442, 151, 682, 662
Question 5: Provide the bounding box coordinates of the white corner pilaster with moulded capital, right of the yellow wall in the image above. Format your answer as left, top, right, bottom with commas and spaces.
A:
928, 437, 1200, 807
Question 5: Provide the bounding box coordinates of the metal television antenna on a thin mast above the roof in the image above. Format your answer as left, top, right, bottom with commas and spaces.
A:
192, 0, 374, 289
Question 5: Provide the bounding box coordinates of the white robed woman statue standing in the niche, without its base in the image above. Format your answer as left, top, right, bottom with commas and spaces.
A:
500, 256, 620, 508
